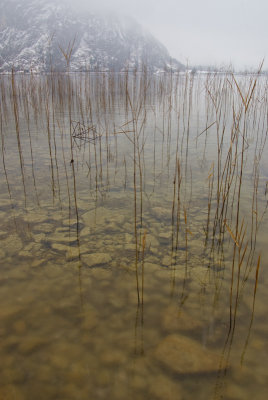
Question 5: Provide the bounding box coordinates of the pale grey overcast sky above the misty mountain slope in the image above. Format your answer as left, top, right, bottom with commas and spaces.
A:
68, 0, 268, 69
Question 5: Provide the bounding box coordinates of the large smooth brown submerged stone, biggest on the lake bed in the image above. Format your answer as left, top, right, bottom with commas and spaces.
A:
154, 334, 220, 374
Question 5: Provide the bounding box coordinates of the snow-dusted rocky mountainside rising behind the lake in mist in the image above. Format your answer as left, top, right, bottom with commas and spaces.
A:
0, 0, 184, 72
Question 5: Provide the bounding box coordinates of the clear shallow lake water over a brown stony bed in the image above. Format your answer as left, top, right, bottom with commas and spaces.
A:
0, 70, 267, 399
